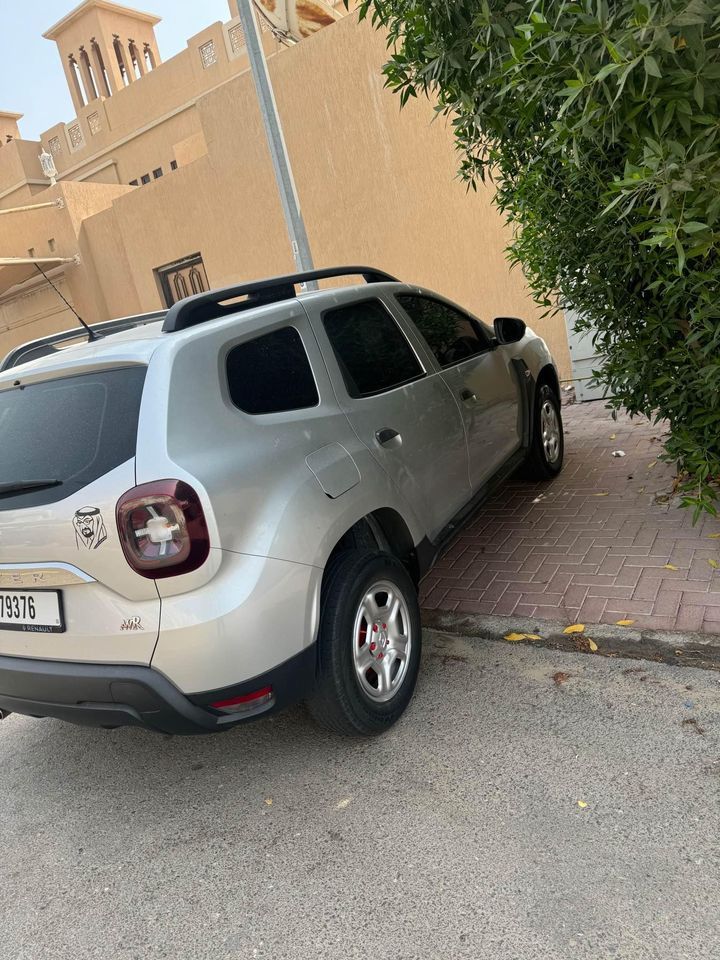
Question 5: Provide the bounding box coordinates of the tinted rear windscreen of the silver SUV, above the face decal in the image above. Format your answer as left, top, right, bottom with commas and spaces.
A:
0, 367, 146, 510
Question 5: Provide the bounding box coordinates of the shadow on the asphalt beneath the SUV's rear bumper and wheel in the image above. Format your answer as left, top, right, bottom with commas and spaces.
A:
0, 639, 460, 819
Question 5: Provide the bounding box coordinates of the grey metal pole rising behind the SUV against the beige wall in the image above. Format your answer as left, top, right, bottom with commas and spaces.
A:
238, 0, 317, 290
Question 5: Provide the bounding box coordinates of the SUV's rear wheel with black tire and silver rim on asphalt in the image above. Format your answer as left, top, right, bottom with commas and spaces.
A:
308, 550, 422, 737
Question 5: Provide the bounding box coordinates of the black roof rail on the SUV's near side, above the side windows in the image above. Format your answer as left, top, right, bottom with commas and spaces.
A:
163, 267, 399, 333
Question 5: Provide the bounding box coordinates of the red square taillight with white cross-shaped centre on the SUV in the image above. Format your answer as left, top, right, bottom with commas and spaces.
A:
116, 480, 210, 580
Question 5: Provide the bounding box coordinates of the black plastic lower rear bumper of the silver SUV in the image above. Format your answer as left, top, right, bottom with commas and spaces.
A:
0, 646, 316, 734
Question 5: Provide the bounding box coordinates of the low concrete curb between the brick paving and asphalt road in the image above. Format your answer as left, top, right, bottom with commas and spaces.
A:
422, 610, 720, 671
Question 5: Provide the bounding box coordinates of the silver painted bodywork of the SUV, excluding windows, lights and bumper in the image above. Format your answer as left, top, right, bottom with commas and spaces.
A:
0, 283, 552, 693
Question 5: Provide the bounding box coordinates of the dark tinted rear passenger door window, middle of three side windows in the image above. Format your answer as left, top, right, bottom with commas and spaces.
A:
323, 300, 424, 397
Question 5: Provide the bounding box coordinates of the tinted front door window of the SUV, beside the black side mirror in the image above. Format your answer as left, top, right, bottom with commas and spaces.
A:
397, 296, 490, 367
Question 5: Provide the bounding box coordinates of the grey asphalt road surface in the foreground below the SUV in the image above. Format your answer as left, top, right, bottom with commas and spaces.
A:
0, 638, 720, 960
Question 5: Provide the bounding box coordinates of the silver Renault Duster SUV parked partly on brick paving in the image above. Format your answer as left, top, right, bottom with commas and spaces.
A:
0, 267, 563, 735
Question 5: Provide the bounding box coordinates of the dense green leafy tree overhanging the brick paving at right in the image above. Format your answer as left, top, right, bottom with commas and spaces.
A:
352, 0, 720, 518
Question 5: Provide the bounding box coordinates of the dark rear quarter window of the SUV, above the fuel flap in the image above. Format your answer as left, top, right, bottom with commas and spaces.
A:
227, 327, 320, 414
